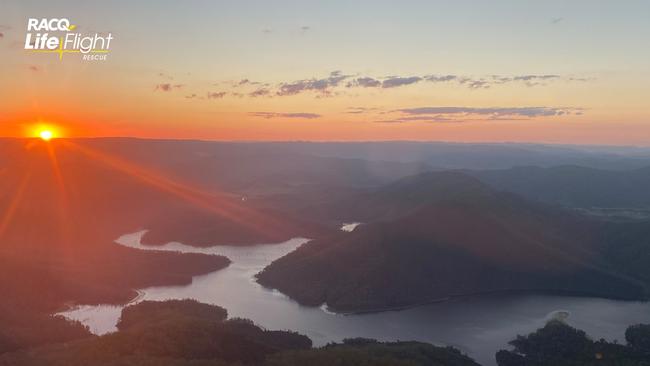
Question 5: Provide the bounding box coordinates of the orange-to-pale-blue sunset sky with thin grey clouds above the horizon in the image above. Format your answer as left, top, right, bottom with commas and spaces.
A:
0, 0, 650, 146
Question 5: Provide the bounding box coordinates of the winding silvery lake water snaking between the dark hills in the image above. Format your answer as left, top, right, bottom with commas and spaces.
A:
60, 228, 650, 365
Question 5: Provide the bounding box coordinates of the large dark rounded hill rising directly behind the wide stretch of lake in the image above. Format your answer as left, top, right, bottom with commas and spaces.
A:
259, 173, 646, 311
